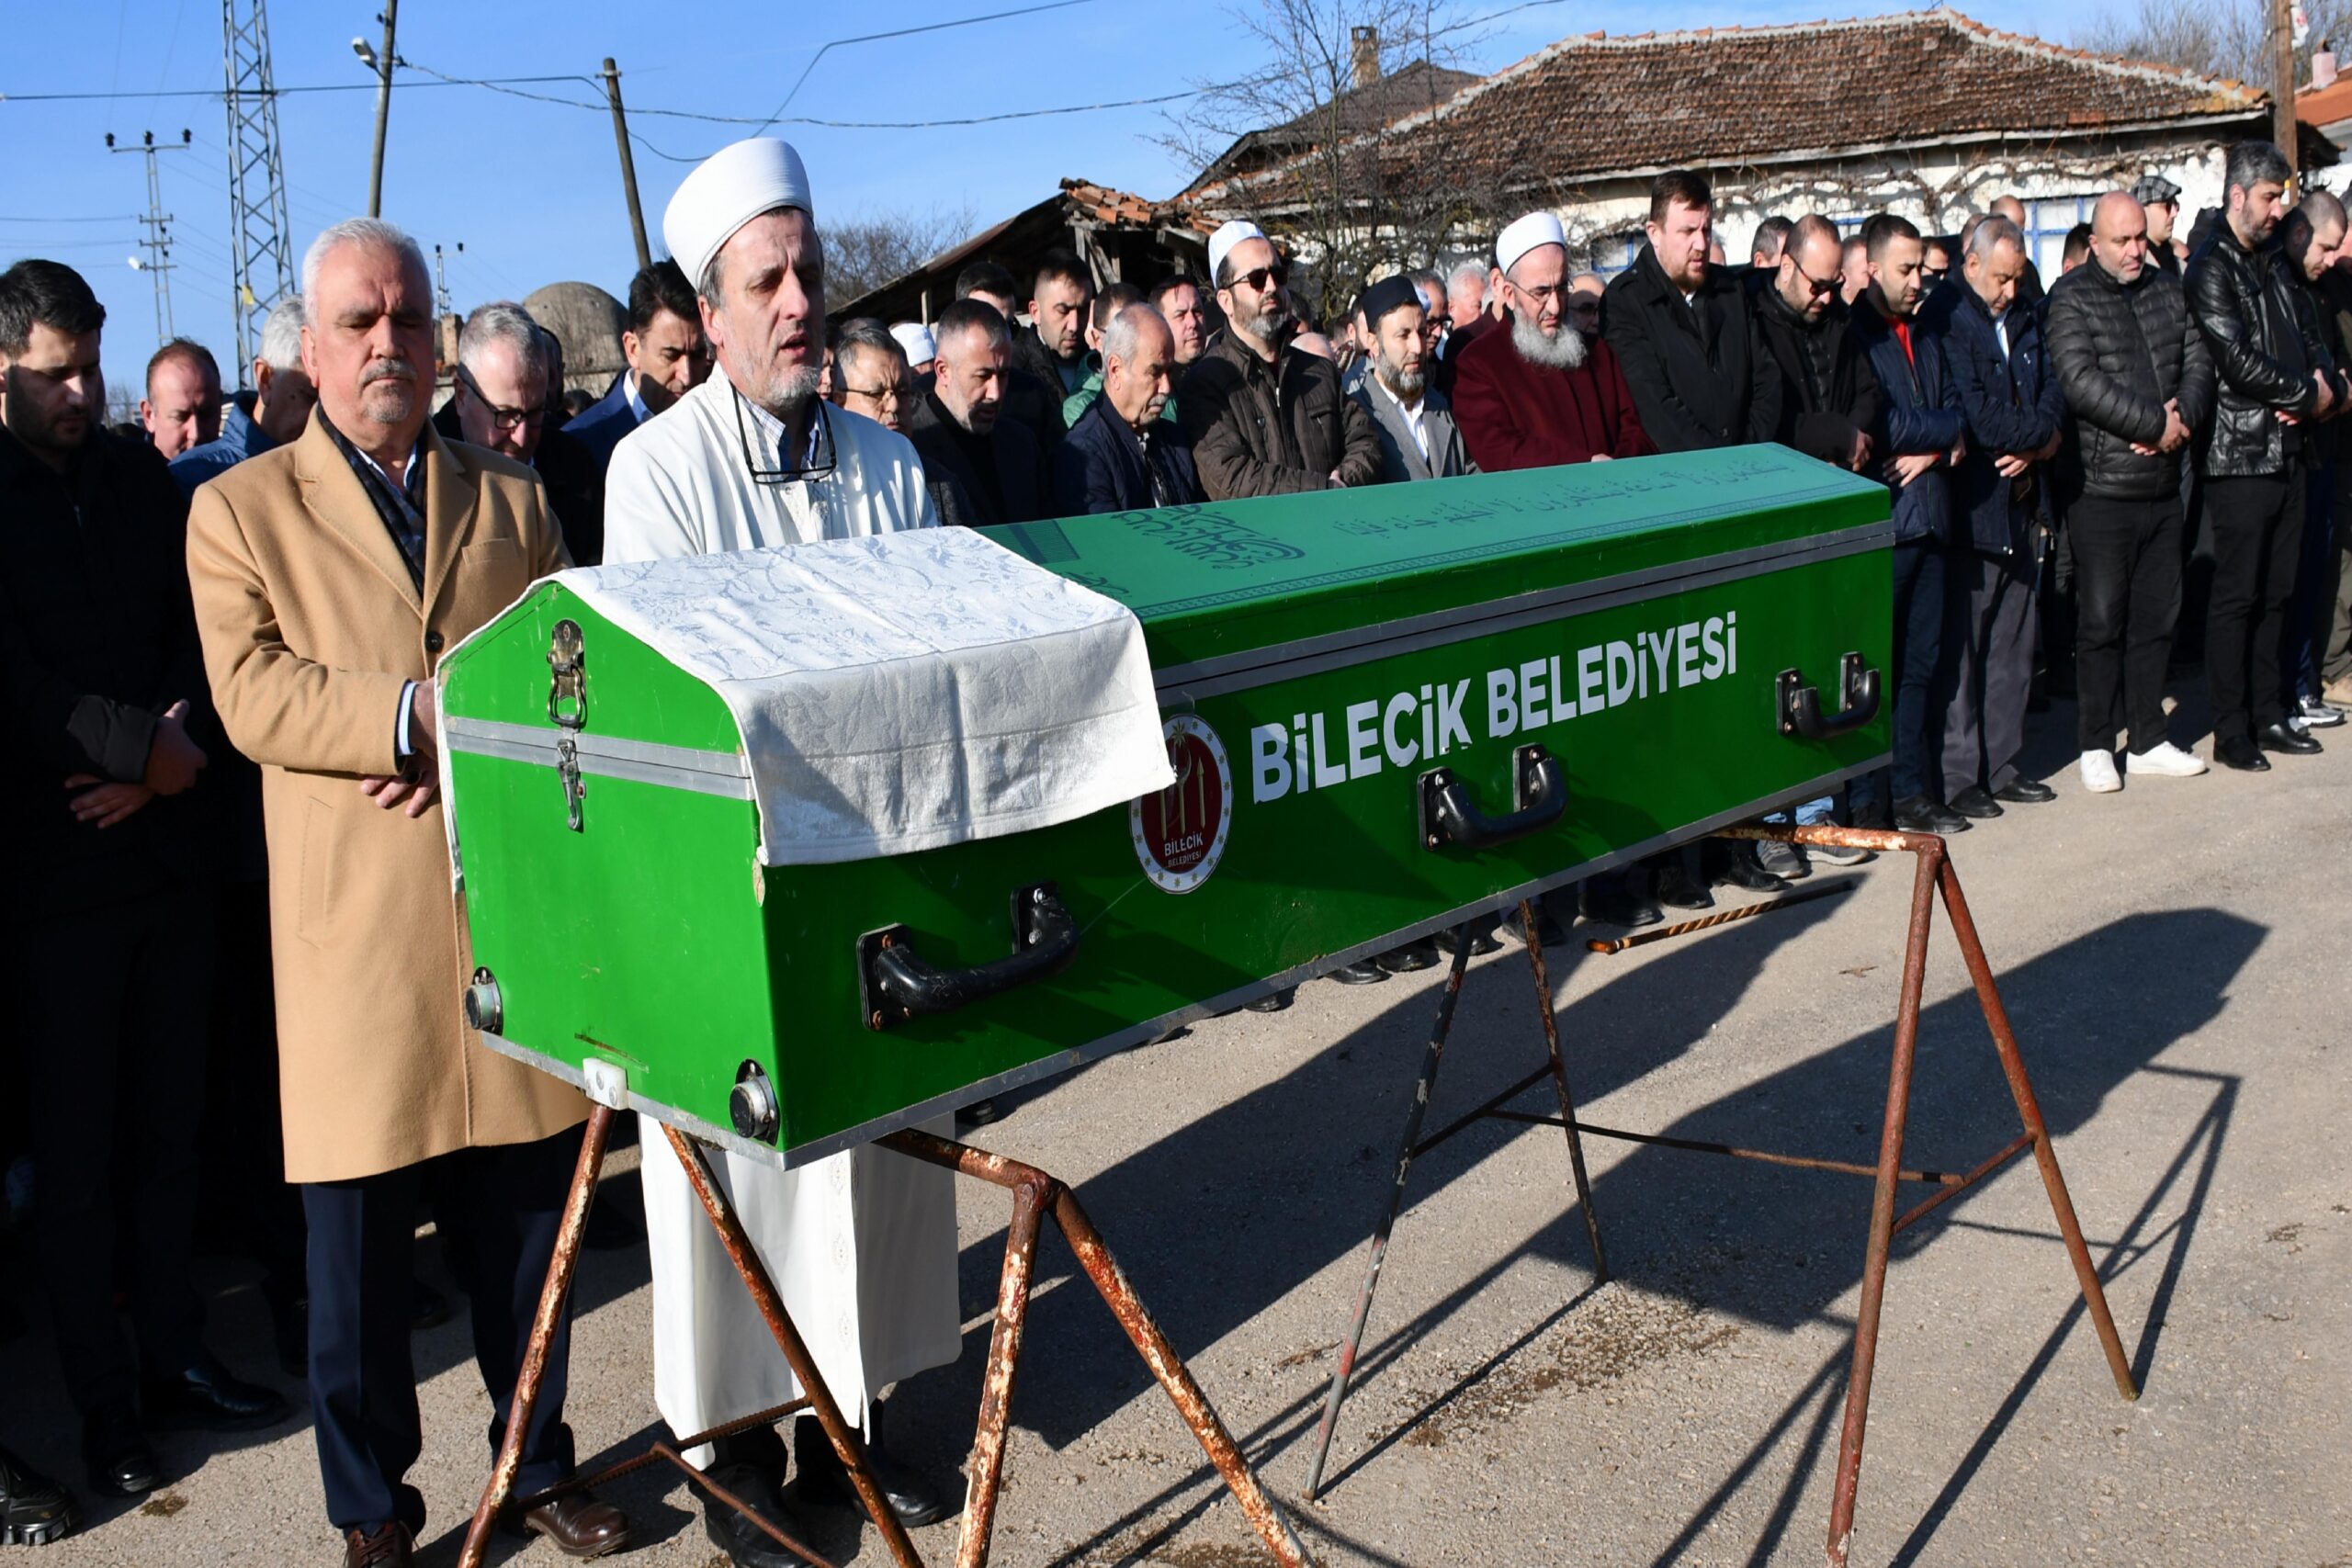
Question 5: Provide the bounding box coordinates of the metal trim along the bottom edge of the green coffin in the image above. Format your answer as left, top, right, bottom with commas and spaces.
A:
482, 752, 1889, 1170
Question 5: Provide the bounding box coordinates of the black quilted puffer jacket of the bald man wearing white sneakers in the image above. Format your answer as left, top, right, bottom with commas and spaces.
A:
2041, 261, 2213, 501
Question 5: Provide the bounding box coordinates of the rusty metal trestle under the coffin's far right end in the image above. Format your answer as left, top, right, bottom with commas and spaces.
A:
1307, 825, 2141, 1568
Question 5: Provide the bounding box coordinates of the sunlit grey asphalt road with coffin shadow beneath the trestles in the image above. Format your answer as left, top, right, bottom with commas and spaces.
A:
0, 707, 2352, 1568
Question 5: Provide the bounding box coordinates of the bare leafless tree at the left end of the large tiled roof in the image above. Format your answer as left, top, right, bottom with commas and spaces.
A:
1159, 0, 1487, 312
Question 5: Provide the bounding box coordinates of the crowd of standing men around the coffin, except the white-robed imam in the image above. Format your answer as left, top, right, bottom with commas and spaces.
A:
0, 129, 2352, 1563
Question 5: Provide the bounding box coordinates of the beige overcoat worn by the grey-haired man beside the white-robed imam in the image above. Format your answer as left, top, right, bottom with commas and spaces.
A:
188, 416, 585, 1182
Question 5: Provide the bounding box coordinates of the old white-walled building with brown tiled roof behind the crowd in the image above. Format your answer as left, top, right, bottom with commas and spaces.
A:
1185, 9, 2304, 288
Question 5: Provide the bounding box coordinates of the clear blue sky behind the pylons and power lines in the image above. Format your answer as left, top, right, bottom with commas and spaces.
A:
0, 0, 2105, 386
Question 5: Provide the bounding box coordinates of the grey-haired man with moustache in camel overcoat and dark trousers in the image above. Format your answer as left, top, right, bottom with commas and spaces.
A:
188, 219, 628, 1568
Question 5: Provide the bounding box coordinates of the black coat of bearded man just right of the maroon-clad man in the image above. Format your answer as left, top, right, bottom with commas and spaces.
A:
1601, 244, 1781, 451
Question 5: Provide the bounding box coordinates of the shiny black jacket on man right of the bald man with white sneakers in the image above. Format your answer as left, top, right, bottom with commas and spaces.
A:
2183, 223, 2326, 479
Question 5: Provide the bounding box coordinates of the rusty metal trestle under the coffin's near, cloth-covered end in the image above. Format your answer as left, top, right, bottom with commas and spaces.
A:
458, 1105, 1312, 1568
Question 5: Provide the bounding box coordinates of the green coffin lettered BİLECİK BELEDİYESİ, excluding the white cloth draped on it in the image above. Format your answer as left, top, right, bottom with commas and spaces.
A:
442, 446, 1894, 1166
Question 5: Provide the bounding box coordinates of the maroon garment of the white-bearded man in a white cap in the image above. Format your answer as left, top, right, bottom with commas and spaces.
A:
1453, 314, 1656, 472
